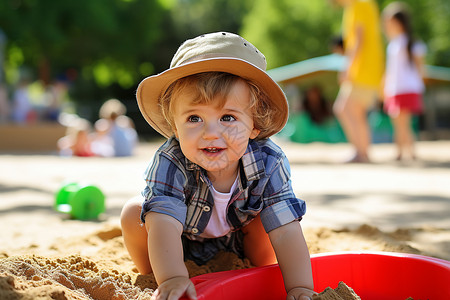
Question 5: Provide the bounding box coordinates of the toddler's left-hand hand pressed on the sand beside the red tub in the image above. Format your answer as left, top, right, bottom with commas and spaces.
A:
151, 276, 197, 300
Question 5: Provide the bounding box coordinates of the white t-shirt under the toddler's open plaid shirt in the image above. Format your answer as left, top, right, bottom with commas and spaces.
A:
200, 176, 239, 238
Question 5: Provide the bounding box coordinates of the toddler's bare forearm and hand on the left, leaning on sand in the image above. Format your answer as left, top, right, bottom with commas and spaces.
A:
145, 212, 197, 300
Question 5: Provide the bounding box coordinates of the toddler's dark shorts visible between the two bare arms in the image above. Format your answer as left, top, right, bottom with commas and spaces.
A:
181, 230, 244, 266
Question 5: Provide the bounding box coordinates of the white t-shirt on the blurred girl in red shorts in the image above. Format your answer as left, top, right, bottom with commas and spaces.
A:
384, 35, 426, 97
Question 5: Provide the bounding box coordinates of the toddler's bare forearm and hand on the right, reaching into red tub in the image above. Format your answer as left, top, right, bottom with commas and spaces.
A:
269, 221, 315, 300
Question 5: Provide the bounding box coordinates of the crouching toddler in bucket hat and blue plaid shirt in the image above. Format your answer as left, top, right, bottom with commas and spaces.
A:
121, 32, 315, 300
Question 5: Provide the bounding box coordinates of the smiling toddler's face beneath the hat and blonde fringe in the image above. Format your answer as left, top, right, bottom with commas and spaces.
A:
173, 80, 260, 176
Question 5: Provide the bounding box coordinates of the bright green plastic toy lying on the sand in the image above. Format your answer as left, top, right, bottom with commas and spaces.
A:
55, 183, 105, 220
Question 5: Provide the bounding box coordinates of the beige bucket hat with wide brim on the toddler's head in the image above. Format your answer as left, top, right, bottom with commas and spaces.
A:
136, 32, 288, 138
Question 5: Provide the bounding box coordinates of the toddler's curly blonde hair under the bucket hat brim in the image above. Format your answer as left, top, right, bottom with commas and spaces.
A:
159, 72, 277, 139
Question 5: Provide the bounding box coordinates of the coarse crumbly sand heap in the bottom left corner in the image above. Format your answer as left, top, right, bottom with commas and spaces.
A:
0, 255, 150, 300
